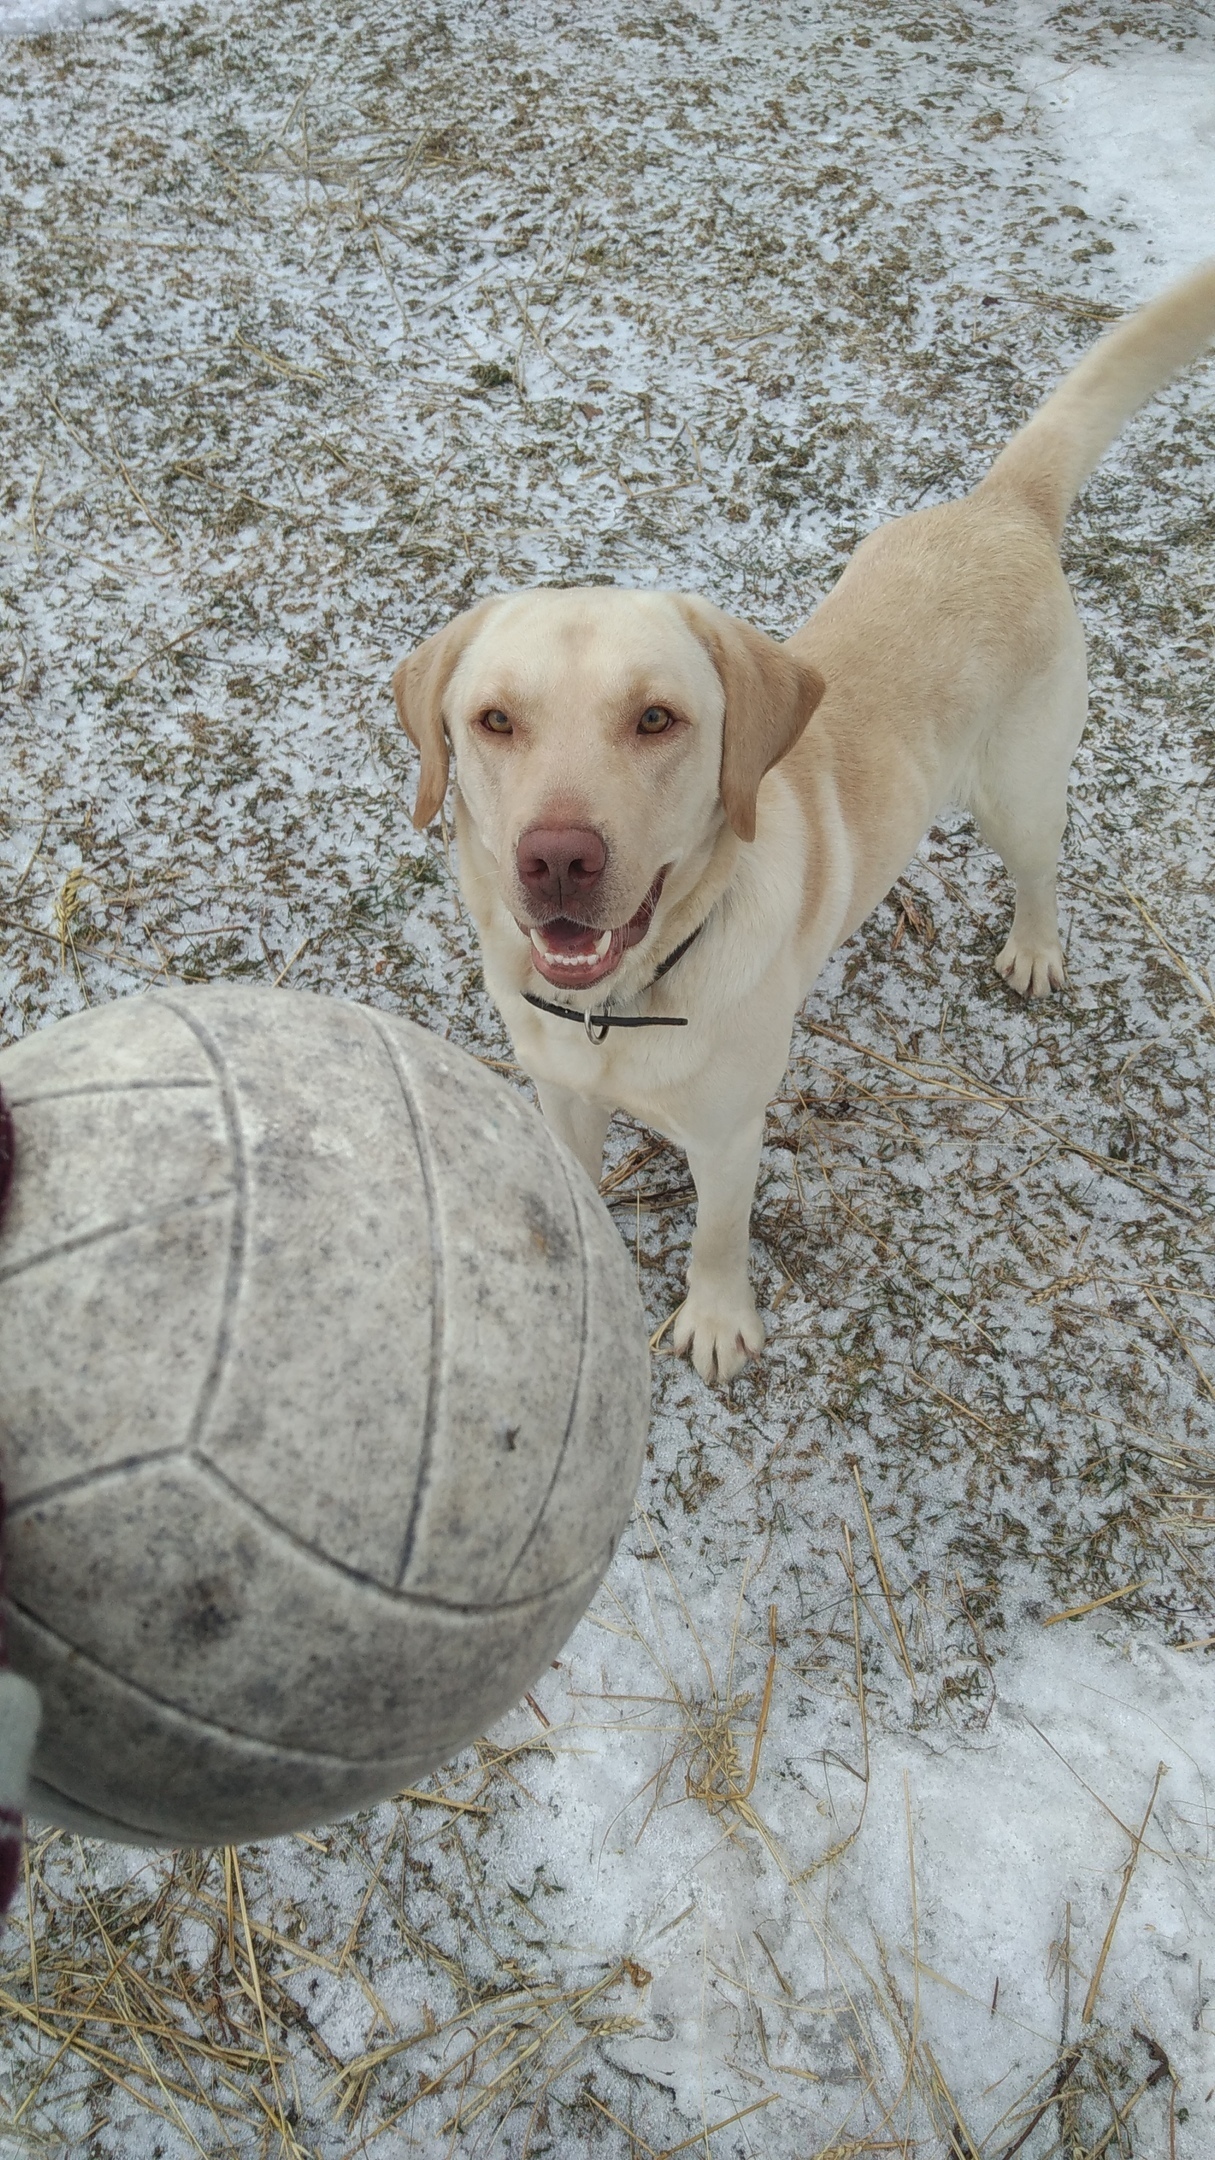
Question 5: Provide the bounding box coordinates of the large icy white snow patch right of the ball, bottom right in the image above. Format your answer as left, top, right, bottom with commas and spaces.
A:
488, 1605, 1215, 2154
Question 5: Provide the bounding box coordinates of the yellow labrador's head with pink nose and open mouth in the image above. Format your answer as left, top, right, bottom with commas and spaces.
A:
393, 585, 824, 989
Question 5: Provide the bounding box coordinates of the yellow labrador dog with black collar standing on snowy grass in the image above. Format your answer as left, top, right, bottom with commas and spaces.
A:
393, 264, 1215, 1380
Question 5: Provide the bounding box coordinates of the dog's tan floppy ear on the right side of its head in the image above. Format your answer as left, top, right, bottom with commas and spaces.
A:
679, 594, 826, 840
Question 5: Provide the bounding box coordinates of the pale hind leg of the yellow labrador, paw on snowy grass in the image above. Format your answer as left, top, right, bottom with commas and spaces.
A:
962, 603, 1087, 998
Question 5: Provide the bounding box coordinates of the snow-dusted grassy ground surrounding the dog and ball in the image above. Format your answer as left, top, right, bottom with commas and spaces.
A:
0, 0, 1215, 2160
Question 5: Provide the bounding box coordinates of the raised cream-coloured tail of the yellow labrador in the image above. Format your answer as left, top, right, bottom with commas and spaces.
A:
977, 261, 1215, 540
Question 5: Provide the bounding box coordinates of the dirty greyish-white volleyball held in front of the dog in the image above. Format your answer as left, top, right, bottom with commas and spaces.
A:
0, 985, 649, 1845
